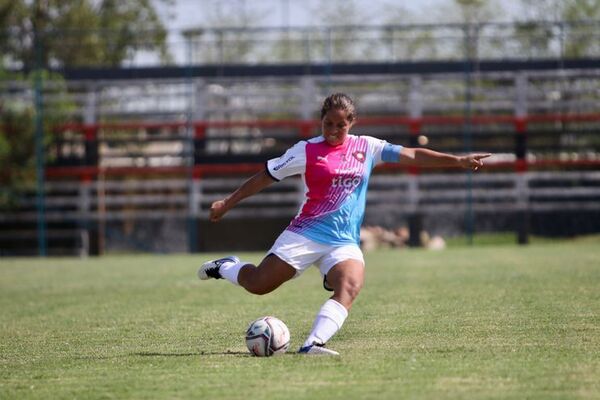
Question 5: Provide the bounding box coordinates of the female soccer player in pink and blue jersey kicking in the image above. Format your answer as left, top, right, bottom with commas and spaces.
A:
198, 93, 490, 355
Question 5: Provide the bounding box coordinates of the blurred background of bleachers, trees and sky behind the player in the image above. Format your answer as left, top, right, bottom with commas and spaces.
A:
0, 0, 600, 256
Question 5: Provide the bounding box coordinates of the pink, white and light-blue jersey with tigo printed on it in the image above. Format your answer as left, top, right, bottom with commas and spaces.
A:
267, 135, 402, 245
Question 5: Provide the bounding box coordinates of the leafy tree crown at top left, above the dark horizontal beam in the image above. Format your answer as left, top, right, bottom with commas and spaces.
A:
0, 0, 172, 70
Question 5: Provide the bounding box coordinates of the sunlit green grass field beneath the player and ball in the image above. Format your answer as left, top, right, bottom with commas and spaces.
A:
0, 240, 600, 399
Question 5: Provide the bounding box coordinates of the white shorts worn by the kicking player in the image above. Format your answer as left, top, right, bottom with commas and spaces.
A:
268, 230, 365, 277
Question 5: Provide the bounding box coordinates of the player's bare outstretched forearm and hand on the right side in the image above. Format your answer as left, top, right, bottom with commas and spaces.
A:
399, 147, 491, 171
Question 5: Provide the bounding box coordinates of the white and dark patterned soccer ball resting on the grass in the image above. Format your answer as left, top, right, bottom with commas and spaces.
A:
246, 317, 290, 357
